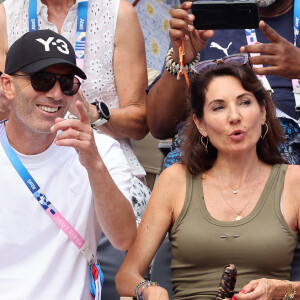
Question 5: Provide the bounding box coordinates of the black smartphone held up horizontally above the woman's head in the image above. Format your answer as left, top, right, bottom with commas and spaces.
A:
192, 0, 259, 29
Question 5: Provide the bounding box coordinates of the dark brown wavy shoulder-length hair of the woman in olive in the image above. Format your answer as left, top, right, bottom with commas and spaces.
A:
181, 64, 286, 175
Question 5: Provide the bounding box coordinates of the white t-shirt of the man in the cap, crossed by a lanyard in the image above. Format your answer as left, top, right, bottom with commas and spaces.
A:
0, 124, 131, 300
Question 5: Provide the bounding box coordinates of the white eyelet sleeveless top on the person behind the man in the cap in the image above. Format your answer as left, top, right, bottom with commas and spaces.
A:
3, 0, 146, 177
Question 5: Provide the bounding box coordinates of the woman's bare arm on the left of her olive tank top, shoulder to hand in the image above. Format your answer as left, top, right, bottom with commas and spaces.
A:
116, 164, 185, 300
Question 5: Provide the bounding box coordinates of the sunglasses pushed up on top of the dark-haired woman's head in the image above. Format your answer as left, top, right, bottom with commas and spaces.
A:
192, 53, 249, 74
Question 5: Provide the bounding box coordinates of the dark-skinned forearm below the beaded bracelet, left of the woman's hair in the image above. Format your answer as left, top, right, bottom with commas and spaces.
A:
146, 71, 187, 139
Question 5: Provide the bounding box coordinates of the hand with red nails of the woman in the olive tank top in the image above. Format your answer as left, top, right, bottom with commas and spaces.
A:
235, 278, 288, 300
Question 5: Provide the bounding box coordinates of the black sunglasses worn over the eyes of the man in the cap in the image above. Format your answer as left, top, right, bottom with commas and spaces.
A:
11, 71, 81, 96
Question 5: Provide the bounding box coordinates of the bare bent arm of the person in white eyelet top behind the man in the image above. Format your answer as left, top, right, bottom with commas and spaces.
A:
90, 0, 148, 140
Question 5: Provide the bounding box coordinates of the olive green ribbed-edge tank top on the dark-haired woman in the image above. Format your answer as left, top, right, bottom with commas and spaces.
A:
170, 165, 298, 300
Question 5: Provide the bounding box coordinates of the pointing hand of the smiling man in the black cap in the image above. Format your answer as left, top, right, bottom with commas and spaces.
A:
51, 100, 101, 169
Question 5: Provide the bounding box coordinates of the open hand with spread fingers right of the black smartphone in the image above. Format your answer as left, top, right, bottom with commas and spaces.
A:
240, 21, 300, 79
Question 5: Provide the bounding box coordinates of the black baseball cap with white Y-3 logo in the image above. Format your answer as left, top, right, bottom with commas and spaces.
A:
5, 29, 86, 79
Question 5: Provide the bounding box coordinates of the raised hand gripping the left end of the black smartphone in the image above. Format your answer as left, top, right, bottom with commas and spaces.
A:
169, 2, 214, 64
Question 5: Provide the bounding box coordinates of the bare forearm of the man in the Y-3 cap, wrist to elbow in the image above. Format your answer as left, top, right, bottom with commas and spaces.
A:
87, 160, 136, 250
